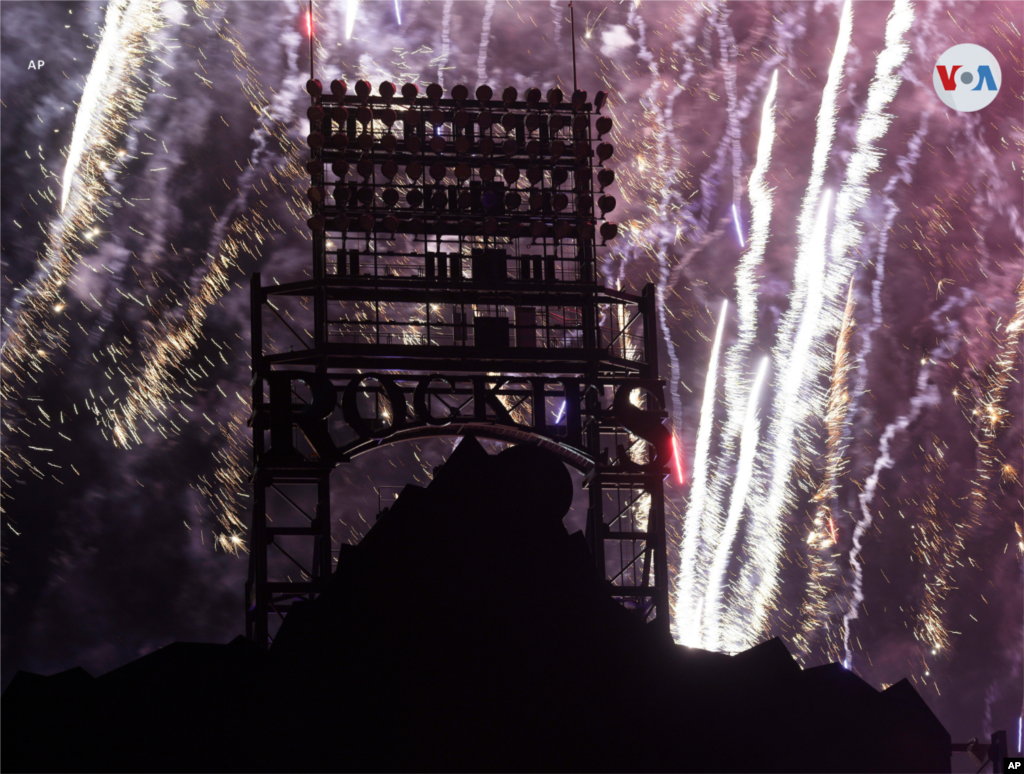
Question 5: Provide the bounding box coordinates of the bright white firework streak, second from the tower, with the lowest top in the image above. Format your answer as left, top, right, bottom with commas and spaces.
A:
702, 357, 770, 650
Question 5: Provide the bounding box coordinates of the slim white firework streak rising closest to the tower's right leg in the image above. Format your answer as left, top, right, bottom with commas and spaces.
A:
675, 300, 729, 647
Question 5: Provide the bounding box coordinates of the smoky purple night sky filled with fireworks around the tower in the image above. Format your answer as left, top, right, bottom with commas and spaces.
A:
0, 0, 1024, 761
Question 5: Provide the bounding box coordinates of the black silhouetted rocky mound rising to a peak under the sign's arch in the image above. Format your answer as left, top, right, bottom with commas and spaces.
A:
0, 438, 949, 774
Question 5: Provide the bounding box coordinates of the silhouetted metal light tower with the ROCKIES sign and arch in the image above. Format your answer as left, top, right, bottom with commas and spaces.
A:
246, 79, 673, 647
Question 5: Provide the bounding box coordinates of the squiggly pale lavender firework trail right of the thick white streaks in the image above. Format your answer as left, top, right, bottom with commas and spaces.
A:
843, 290, 972, 669
